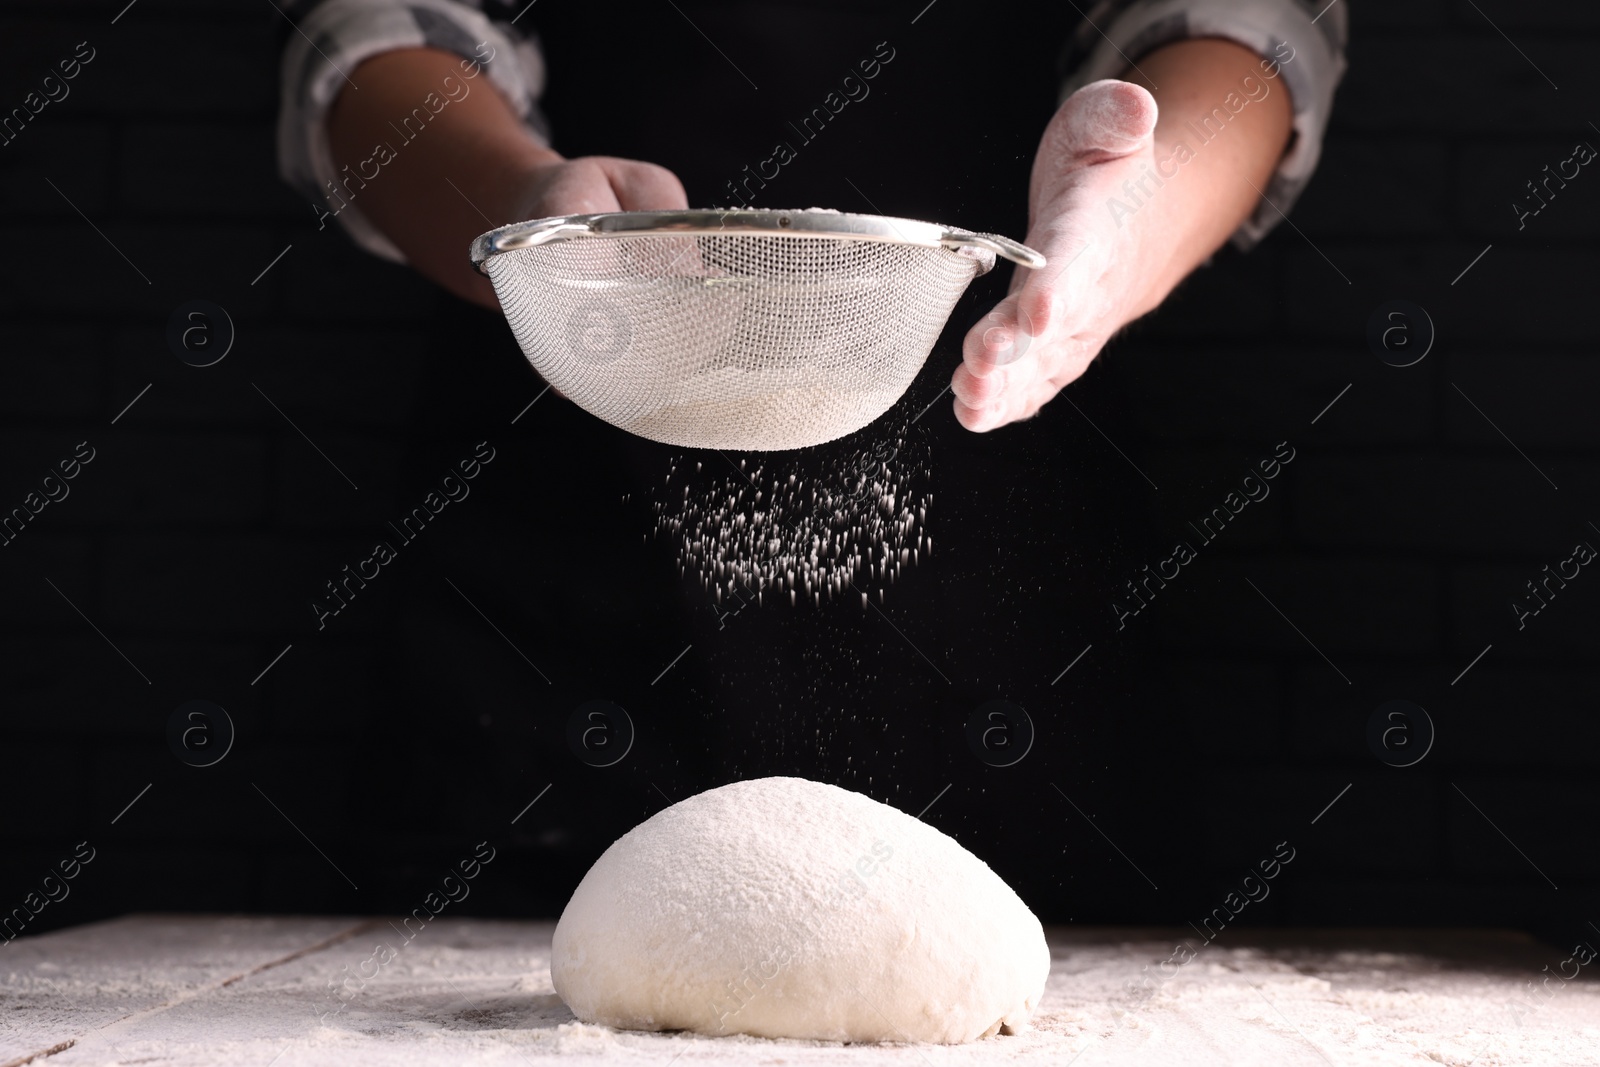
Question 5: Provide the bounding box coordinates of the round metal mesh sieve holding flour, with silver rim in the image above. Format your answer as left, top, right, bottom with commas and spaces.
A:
472, 208, 1045, 451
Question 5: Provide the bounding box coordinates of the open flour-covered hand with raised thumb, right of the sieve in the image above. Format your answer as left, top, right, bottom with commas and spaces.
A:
950, 80, 1165, 432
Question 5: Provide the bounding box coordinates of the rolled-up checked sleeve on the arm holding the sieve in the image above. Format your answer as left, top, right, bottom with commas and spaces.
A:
277, 0, 549, 262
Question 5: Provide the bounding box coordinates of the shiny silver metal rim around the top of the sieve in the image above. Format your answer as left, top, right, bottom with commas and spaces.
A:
470, 208, 1045, 274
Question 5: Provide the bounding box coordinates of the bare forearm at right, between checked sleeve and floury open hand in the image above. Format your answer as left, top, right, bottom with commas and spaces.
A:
1123, 38, 1293, 320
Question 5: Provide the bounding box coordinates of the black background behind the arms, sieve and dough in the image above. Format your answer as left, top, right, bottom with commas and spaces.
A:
0, 0, 1600, 942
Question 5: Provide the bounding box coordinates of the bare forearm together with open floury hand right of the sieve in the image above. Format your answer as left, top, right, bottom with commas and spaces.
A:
950, 38, 1293, 432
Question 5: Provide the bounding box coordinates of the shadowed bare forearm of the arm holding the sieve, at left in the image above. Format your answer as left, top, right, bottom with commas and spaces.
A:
328, 48, 562, 307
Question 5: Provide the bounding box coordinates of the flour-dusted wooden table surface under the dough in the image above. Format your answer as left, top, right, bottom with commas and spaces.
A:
0, 915, 1600, 1067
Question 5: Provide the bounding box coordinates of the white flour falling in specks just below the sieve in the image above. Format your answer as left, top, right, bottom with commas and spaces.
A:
654, 426, 933, 608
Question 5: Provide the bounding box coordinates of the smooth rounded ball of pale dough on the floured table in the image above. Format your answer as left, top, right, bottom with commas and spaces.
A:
550, 777, 1050, 1043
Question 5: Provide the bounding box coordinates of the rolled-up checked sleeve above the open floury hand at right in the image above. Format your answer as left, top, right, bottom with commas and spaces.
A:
1061, 0, 1349, 250
